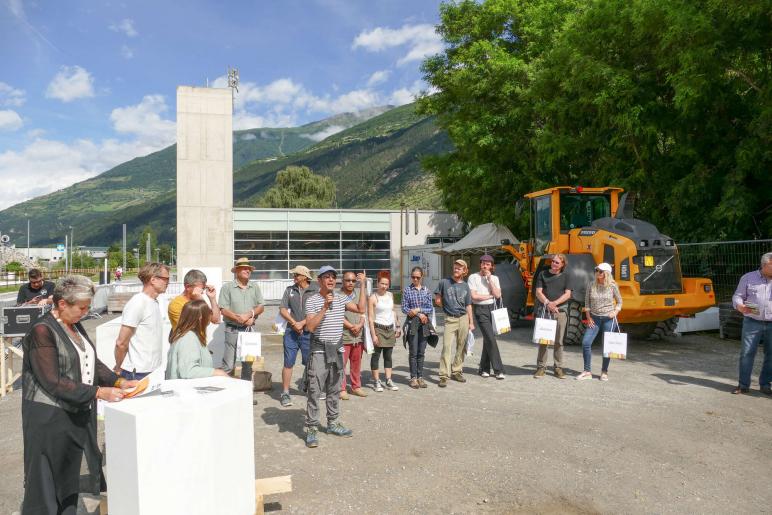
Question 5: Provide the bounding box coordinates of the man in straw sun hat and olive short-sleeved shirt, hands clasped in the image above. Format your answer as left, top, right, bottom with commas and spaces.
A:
220, 257, 265, 380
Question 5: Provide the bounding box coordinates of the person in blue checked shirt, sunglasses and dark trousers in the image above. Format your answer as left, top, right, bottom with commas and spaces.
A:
402, 266, 434, 389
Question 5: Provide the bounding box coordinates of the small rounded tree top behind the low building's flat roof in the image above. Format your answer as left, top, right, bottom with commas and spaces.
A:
259, 166, 335, 209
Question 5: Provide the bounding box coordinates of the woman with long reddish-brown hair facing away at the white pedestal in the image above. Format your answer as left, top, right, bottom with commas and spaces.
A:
166, 300, 228, 379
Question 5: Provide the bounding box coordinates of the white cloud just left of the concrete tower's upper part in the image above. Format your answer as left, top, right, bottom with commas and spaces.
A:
110, 95, 177, 144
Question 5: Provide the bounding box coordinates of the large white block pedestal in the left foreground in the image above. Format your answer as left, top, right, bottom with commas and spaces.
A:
105, 377, 255, 515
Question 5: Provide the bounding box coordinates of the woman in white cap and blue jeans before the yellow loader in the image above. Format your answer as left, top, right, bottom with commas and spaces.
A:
576, 263, 622, 381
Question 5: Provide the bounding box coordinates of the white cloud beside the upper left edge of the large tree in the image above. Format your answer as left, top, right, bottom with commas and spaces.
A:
351, 23, 443, 65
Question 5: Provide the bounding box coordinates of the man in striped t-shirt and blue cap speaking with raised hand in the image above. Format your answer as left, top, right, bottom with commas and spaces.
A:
306, 265, 367, 447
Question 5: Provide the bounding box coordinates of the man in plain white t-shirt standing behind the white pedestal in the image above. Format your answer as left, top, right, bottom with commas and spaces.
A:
114, 263, 169, 379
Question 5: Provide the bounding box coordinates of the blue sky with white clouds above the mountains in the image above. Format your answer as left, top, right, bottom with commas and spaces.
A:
0, 0, 442, 209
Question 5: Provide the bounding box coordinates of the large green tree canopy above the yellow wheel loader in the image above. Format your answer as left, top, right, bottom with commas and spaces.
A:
419, 0, 772, 241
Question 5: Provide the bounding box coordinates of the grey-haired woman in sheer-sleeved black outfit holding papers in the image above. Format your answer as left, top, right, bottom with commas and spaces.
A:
21, 275, 136, 515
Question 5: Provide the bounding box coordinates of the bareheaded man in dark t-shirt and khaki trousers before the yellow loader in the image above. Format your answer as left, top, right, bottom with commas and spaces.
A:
533, 254, 571, 379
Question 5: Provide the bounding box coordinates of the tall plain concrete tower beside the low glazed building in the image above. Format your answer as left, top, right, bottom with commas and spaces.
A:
177, 86, 233, 280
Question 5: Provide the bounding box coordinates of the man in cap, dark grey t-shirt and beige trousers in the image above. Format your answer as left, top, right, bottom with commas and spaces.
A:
434, 259, 474, 388
